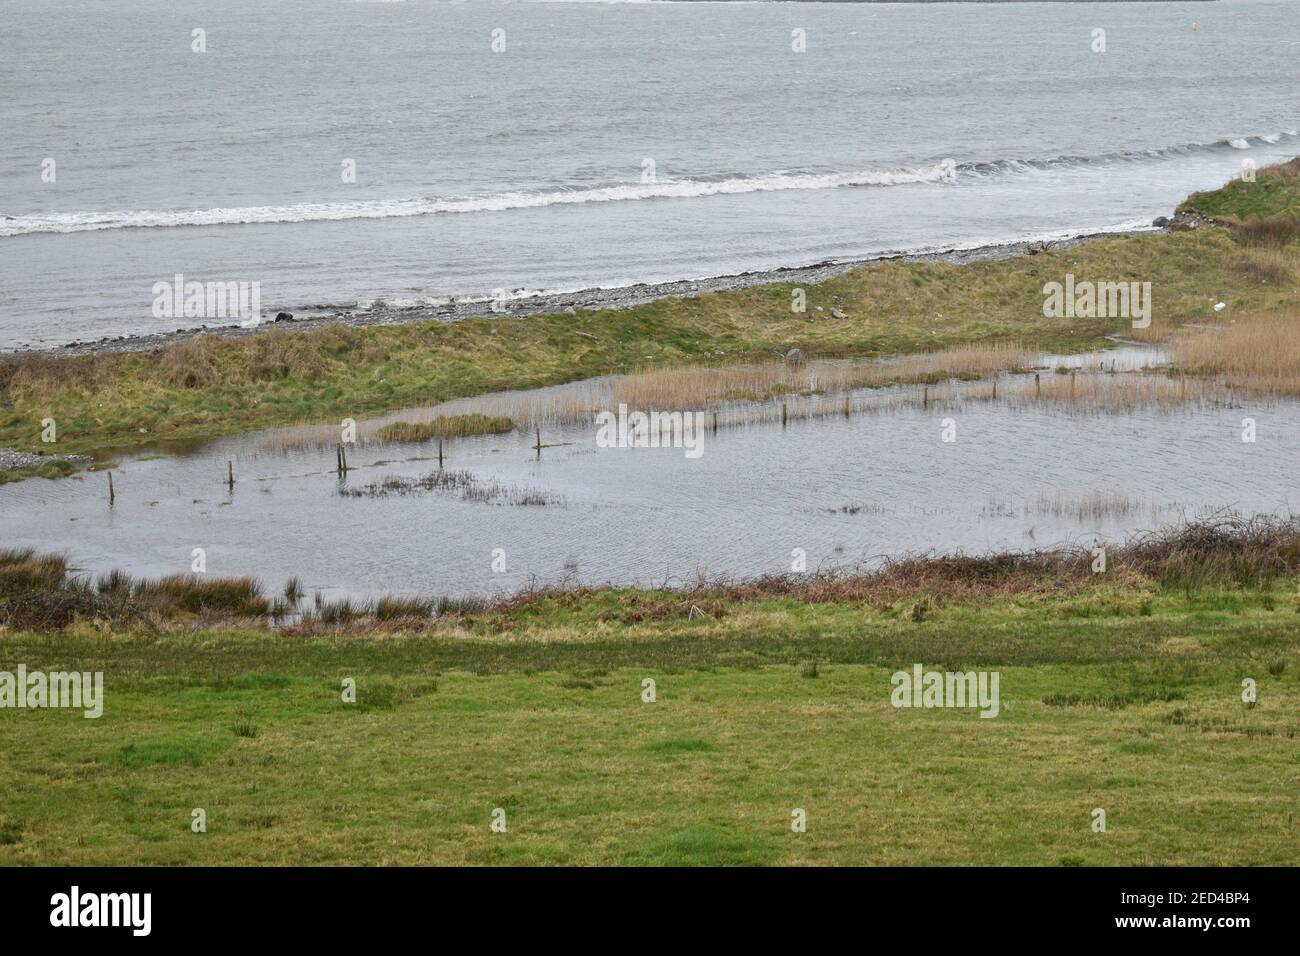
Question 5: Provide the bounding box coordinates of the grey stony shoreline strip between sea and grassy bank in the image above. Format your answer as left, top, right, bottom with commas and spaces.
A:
15, 223, 1175, 360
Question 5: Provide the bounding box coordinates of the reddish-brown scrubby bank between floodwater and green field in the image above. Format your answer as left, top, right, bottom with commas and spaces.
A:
0, 520, 1300, 640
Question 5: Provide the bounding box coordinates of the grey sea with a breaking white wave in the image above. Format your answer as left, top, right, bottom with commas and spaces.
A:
0, 0, 1300, 350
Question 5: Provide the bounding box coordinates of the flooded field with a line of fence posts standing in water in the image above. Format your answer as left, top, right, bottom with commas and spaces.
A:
0, 347, 1300, 598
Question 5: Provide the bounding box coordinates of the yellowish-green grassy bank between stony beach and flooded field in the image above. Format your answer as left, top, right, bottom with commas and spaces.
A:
0, 164, 1300, 463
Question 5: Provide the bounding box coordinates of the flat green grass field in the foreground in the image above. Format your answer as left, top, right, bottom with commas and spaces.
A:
0, 580, 1300, 865
